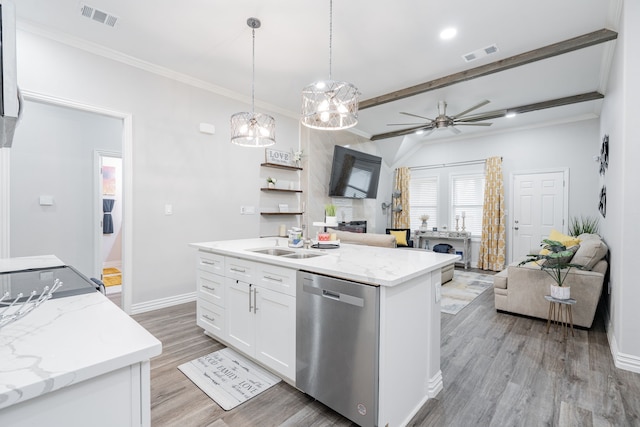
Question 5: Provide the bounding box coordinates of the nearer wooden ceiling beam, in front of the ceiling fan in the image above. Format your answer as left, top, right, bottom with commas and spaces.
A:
358, 28, 618, 110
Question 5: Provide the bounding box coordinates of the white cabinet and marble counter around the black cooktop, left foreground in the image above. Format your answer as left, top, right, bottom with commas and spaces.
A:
0, 256, 162, 427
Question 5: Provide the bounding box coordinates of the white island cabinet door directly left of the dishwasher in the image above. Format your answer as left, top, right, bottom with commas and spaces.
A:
254, 287, 296, 381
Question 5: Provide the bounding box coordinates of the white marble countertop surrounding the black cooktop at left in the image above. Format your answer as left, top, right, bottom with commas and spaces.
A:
0, 257, 162, 409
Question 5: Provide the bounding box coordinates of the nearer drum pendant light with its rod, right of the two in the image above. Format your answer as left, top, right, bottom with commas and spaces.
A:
301, 0, 360, 130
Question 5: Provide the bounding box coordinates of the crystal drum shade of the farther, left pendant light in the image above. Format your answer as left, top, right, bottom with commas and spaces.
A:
231, 112, 276, 147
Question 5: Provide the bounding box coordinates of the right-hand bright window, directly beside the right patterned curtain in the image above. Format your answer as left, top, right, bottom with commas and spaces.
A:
451, 174, 484, 236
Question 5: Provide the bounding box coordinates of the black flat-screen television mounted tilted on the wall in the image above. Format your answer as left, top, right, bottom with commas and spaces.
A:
329, 145, 382, 199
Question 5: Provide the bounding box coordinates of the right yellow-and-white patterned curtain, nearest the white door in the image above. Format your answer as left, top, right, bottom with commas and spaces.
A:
478, 157, 506, 271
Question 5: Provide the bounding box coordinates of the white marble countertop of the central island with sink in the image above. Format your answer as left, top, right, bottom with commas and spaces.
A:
189, 237, 460, 286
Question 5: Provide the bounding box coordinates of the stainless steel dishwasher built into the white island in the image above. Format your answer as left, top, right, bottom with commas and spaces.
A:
296, 271, 380, 426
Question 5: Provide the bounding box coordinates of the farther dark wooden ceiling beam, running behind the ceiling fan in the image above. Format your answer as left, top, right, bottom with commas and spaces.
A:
371, 92, 604, 141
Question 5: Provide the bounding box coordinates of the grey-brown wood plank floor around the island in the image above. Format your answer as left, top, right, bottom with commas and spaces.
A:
134, 272, 640, 427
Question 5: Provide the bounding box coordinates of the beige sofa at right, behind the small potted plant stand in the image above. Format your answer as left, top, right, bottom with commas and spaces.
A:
493, 234, 608, 328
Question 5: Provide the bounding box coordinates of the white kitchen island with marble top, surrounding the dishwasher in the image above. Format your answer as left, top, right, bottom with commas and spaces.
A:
190, 238, 459, 426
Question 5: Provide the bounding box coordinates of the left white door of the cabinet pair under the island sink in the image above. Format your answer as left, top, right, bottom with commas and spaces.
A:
225, 277, 255, 357
